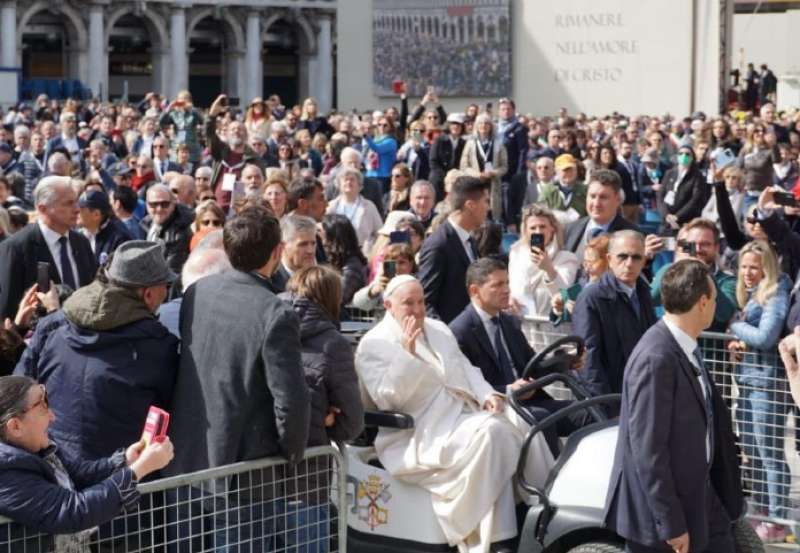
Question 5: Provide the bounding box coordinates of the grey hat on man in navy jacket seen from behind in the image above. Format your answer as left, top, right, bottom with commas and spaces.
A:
106, 240, 177, 288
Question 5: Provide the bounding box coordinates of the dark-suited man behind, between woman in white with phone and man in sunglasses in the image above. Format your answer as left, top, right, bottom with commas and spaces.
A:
564, 169, 639, 258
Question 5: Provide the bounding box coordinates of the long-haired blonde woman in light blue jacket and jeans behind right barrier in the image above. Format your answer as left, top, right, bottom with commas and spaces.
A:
728, 240, 792, 543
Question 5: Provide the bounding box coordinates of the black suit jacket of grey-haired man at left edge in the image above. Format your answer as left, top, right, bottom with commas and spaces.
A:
0, 223, 97, 319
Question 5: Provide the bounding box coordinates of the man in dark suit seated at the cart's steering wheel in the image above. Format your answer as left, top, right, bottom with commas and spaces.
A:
449, 257, 575, 455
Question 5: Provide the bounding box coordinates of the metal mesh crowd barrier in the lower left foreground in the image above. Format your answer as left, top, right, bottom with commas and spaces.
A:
0, 446, 347, 553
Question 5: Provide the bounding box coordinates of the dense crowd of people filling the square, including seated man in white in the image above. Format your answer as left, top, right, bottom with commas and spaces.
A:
0, 83, 800, 551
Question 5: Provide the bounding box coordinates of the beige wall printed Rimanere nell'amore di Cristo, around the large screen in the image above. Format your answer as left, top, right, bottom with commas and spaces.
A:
337, 0, 720, 114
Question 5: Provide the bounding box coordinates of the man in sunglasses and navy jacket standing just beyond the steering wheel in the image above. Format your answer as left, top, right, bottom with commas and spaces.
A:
572, 230, 656, 410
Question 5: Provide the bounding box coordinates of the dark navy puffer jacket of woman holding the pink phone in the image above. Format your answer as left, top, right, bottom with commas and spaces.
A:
0, 442, 139, 552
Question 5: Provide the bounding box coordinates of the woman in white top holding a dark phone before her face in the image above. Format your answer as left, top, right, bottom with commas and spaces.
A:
508, 204, 580, 350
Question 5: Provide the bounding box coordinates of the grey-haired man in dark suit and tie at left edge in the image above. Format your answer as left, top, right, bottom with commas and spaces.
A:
0, 176, 97, 319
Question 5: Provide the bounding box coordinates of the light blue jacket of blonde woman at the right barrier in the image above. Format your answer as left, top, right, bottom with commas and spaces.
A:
731, 273, 792, 389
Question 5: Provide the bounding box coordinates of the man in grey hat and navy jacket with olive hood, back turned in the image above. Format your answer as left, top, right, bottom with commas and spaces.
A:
15, 240, 178, 459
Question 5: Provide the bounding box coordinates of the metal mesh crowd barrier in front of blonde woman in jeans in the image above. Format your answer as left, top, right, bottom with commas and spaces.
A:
523, 317, 800, 539
